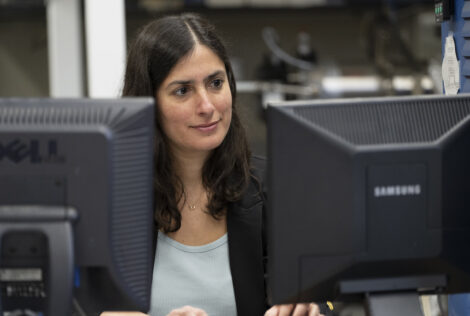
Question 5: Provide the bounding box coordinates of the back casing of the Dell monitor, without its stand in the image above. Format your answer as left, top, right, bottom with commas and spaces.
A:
0, 98, 154, 312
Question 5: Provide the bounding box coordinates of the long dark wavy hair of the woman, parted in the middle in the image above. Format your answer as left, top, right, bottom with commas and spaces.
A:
122, 14, 250, 233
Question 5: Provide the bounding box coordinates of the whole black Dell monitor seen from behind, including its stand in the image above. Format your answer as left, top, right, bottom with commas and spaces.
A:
0, 98, 154, 316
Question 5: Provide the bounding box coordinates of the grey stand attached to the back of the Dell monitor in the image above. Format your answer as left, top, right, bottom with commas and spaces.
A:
0, 206, 77, 316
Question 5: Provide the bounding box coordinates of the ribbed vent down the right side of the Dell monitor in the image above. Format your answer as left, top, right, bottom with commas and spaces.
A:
111, 126, 153, 302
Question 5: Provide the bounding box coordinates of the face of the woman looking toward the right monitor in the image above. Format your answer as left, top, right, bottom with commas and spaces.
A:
156, 44, 232, 154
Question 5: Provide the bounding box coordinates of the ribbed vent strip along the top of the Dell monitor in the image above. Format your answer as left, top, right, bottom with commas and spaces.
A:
0, 105, 119, 126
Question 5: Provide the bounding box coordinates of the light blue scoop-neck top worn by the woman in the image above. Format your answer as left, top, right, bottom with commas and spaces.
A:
149, 232, 237, 316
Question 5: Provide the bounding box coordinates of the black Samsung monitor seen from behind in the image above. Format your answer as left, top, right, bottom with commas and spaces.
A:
267, 95, 470, 303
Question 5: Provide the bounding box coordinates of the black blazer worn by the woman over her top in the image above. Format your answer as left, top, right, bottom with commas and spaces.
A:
154, 157, 268, 316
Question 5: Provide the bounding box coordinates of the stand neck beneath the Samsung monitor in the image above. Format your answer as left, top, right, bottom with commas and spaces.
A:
366, 292, 424, 316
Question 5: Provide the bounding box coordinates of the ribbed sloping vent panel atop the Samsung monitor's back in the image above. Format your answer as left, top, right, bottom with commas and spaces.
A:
293, 98, 470, 145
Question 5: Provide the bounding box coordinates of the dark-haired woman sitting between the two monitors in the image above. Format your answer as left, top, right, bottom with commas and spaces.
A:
107, 14, 319, 316
